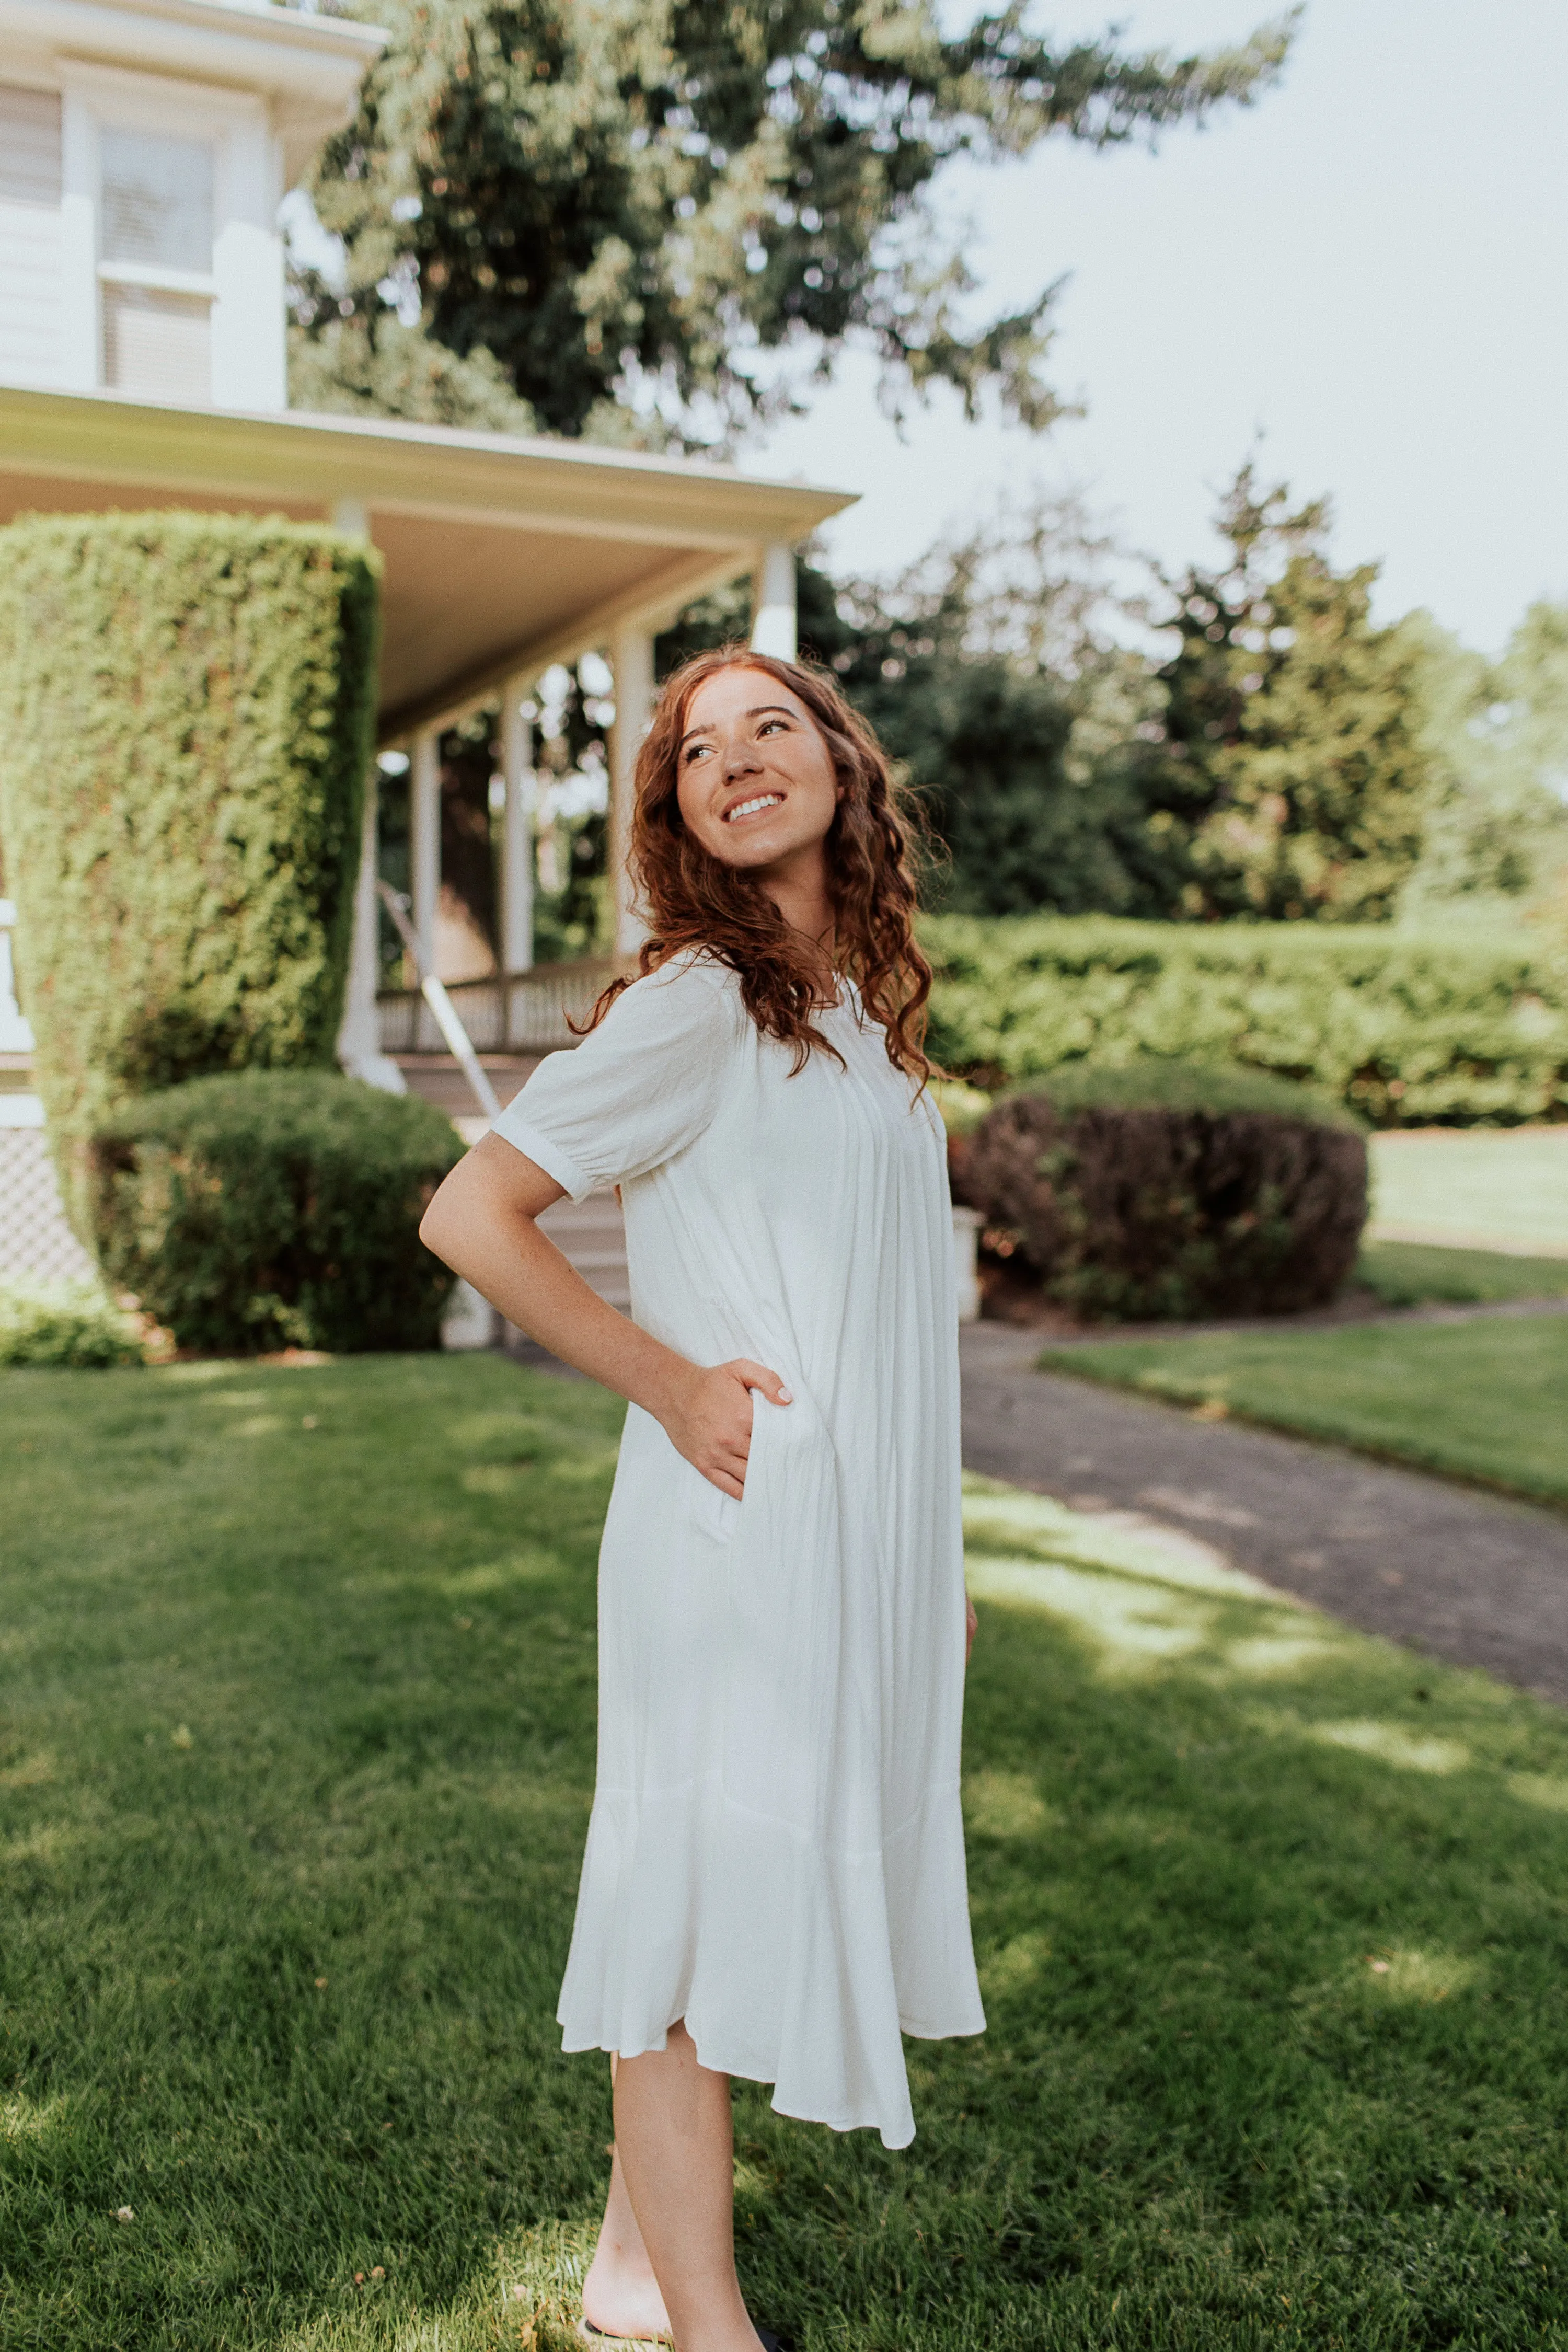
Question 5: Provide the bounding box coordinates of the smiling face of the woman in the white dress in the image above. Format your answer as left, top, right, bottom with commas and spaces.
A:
677, 668, 841, 880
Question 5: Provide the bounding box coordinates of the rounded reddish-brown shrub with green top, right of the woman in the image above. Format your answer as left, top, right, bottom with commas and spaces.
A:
959, 1066, 1366, 1322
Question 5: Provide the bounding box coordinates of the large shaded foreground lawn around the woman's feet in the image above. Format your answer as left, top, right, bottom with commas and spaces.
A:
0, 1355, 1568, 2352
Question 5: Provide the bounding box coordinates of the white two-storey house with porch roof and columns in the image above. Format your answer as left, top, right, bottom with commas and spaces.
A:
0, 0, 851, 1273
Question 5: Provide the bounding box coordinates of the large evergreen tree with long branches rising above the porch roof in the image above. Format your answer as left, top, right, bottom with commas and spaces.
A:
296, 0, 1293, 442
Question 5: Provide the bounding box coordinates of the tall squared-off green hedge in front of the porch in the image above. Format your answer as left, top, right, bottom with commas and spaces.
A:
0, 513, 378, 1232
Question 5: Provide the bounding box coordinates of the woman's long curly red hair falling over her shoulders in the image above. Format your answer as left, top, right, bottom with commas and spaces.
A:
587, 644, 933, 1082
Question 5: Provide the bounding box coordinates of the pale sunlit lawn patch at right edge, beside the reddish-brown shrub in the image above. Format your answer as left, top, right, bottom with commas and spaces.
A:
1368, 1127, 1568, 1259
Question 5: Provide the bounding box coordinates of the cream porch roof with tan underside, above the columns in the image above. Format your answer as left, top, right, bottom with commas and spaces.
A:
0, 386, 856, 741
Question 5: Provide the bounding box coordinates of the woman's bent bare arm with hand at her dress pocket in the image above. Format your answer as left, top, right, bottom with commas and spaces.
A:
419, 1136, 792, 1496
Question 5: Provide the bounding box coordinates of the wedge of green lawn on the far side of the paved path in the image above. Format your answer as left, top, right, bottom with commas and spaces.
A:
1039, 1315, 1568, 1503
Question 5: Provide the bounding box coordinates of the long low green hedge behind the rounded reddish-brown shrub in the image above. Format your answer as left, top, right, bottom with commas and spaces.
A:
921, 915, 1568, 1127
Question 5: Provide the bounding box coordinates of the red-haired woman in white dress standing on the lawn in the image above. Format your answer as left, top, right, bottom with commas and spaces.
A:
421, 647, 985, 2352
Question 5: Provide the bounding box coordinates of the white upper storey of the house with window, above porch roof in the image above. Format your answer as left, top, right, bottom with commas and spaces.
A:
0, 0, 383, 409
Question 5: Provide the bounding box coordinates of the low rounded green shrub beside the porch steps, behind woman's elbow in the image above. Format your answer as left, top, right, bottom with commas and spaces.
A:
91, 1070, 463, 1355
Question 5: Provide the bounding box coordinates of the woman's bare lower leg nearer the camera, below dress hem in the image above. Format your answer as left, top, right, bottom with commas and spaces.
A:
616, 2023, 757, 2352
